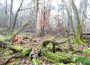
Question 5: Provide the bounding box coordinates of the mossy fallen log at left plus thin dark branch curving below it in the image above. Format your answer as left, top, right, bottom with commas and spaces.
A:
0, 42, 32, 65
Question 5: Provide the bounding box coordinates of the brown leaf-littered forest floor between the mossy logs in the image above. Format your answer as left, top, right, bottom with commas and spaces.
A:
0, 34, 87, 65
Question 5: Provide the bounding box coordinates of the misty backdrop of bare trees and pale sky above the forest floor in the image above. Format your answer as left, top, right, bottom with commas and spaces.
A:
0, 0, 90, 35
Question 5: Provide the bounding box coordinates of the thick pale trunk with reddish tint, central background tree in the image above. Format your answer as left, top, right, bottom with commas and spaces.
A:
36, 0, 51, 36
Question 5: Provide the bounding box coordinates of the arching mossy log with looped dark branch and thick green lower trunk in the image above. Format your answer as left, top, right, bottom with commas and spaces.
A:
40, 40, 73, 63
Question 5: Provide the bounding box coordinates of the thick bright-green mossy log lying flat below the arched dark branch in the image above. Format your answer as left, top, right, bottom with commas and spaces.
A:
43, 51, 73, 63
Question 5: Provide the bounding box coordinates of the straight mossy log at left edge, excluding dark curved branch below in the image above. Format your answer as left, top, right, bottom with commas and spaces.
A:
0, 42, 32, 56
